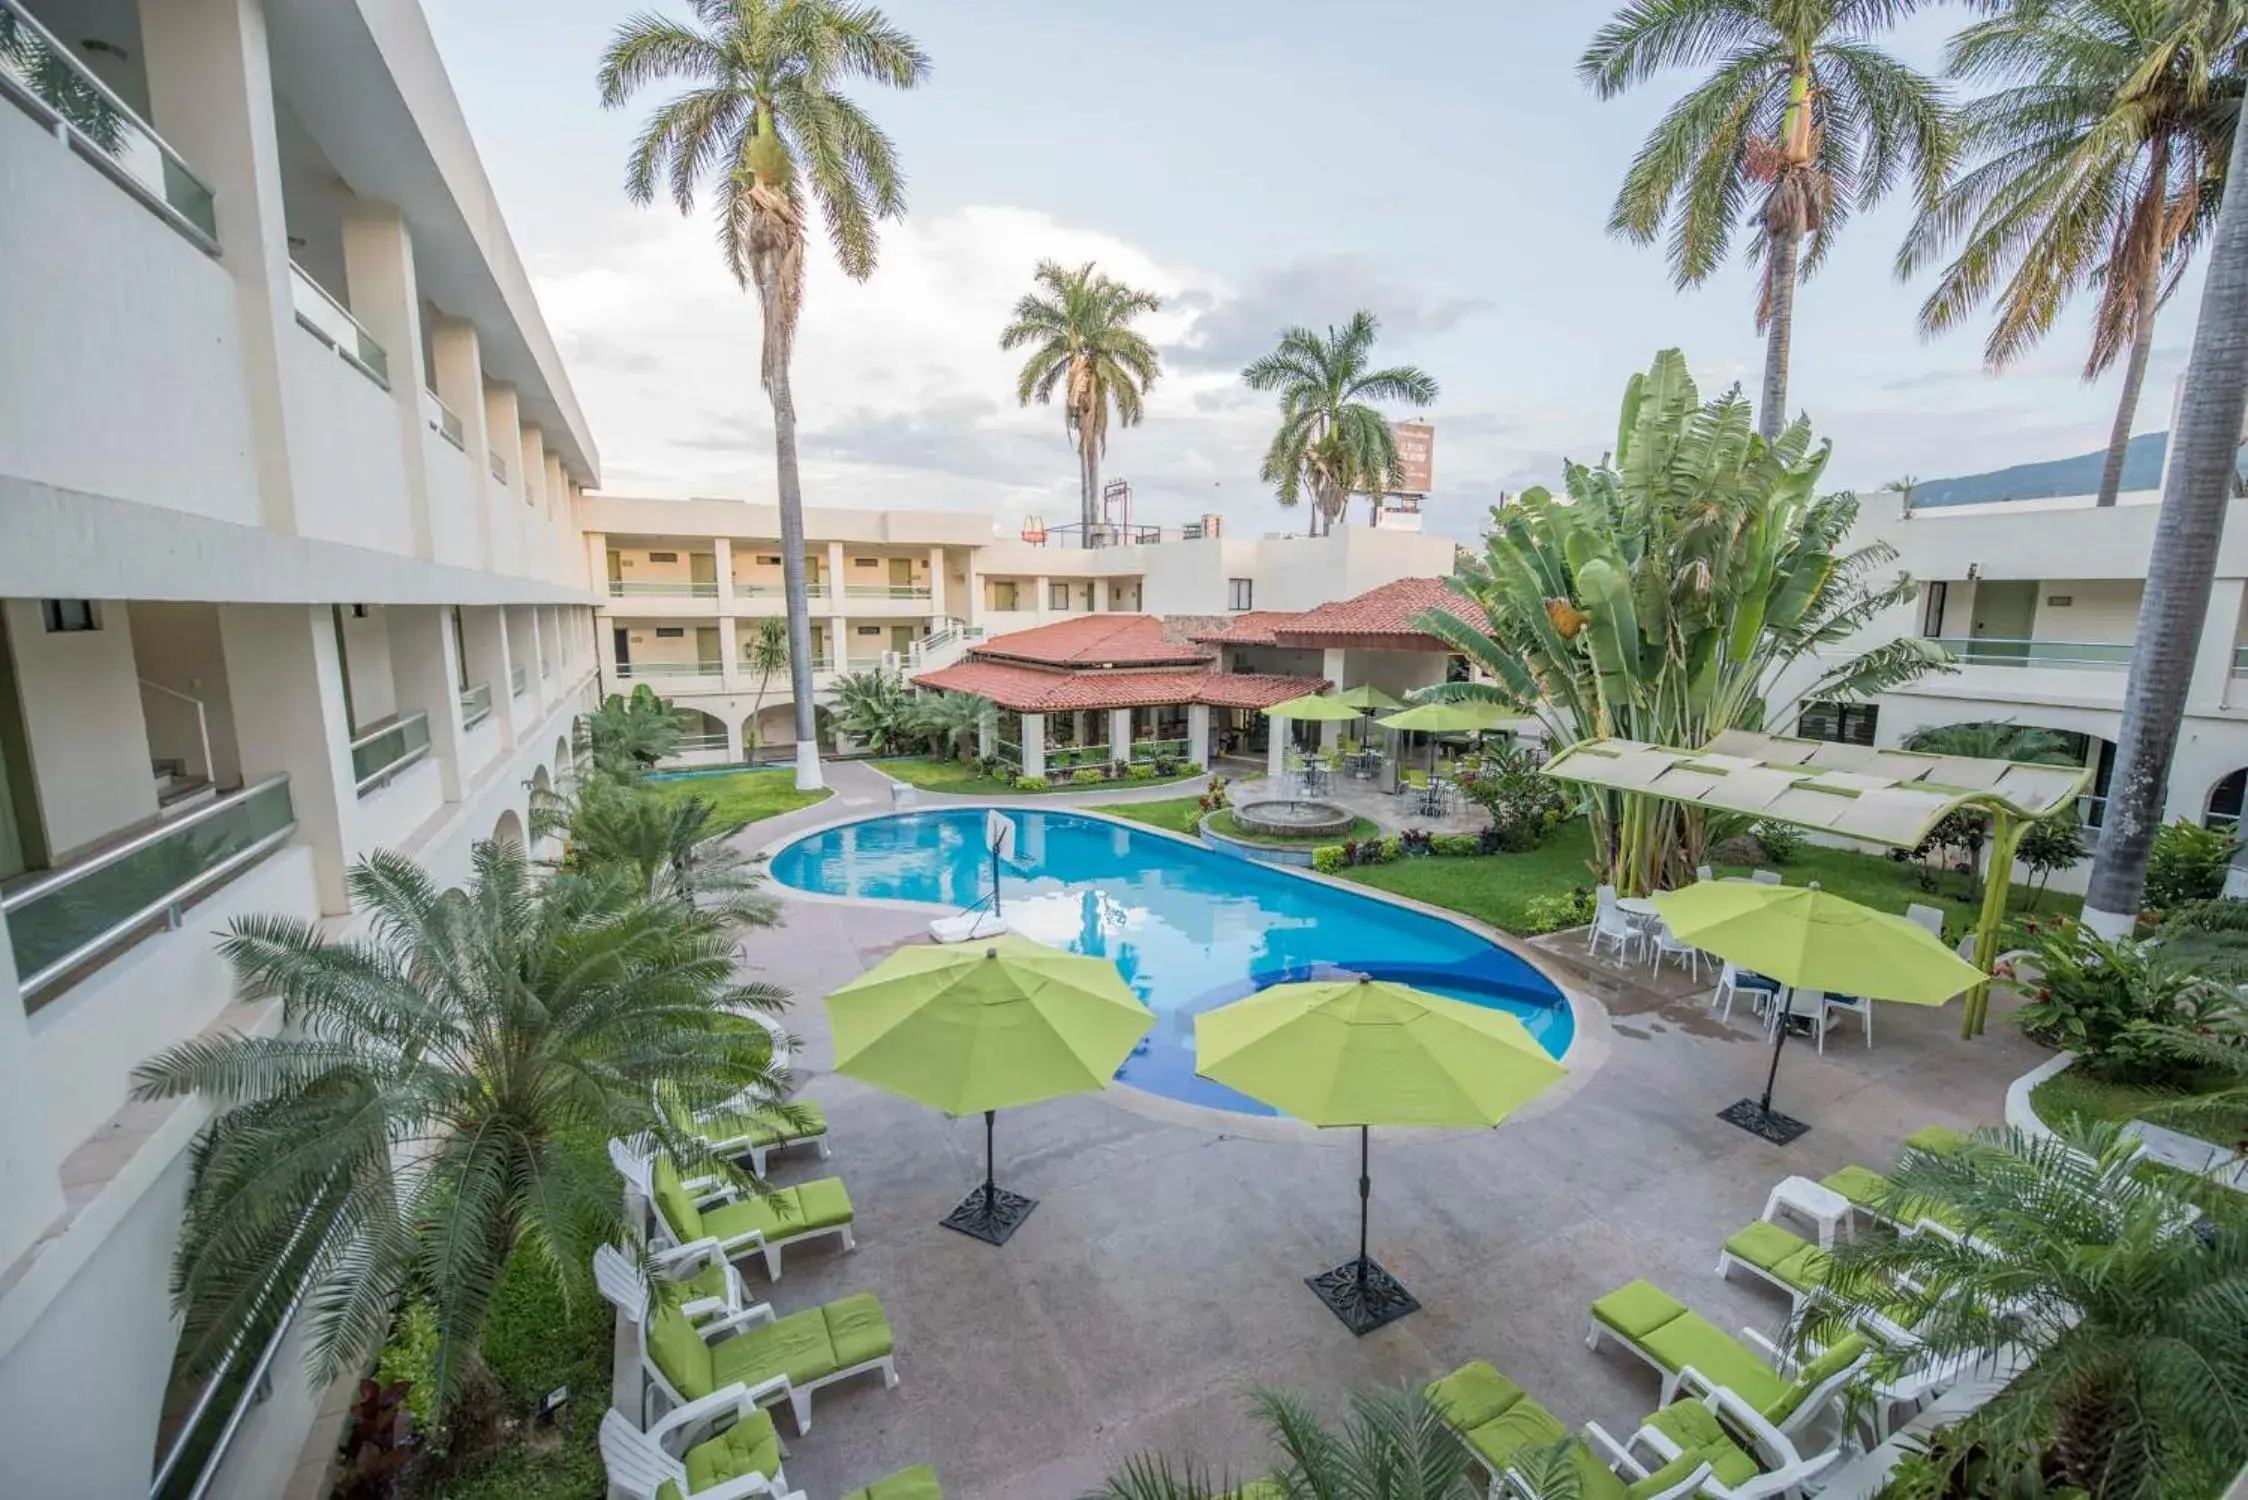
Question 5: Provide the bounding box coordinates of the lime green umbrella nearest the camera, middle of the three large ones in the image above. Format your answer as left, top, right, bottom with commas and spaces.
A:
1194, 974, 1567, 1334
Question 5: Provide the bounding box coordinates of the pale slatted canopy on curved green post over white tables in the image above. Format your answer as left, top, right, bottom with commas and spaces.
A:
1544, 729, 2093, 1037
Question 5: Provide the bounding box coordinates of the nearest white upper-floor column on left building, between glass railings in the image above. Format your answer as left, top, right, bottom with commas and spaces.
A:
139, 0, 306, 535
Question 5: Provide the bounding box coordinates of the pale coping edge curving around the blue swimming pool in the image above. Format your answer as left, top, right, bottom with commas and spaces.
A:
753, 801, 1614, 1147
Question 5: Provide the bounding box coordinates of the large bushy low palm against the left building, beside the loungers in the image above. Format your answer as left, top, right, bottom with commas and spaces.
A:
135, 843, 785, 1412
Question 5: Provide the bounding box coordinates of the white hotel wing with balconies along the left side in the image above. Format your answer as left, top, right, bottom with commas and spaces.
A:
0, 0, 600, 1500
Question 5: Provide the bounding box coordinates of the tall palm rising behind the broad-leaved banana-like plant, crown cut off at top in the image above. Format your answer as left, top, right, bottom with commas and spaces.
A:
1576, 0, 1956, 443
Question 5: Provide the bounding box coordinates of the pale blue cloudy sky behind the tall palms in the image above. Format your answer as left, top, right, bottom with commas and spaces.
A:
425, 0, 2201, 540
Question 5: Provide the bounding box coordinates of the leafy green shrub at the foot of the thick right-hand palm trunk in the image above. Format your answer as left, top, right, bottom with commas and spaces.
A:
1998, 918, 2232, 1084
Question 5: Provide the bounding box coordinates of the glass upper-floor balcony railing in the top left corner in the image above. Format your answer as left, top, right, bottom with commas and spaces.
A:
0, 0, 218, 254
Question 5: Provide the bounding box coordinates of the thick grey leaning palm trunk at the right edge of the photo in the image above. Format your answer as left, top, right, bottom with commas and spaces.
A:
2084, 110, 2248, 938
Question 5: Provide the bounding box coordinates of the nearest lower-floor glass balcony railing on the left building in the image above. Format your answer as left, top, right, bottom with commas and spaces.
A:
0, 776, 297, 1010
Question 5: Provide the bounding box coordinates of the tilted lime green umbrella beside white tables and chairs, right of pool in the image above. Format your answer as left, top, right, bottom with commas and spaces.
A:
1655, 879, 1985, 1145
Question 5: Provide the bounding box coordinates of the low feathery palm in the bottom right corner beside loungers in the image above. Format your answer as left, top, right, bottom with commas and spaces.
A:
1796, 1118, 2248, 1500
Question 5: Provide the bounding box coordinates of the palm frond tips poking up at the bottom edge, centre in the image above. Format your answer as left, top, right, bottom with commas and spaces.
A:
1086, 1390, 1479, 1500
